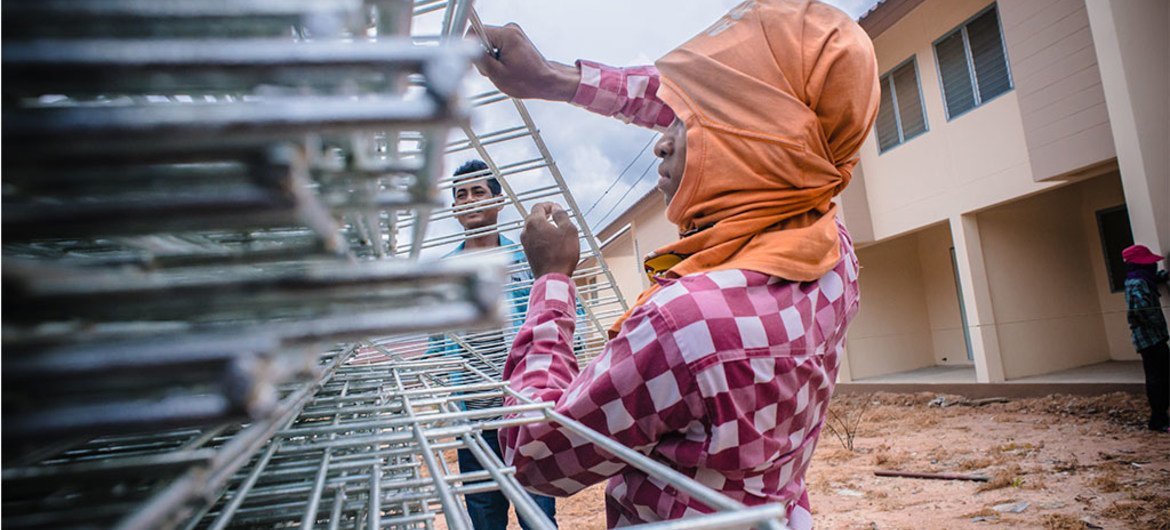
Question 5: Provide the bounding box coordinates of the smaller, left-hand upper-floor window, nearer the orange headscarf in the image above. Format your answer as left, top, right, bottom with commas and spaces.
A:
876, 57, 927, 152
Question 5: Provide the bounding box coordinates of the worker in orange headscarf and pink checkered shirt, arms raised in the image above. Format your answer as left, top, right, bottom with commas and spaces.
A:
479, 0, 879, 529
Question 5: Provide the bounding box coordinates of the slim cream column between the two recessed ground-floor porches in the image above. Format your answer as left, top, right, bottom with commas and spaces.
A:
950, 215, 1004, 383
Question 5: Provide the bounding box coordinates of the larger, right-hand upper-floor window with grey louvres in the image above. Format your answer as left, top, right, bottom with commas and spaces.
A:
935, 5, 1012, 119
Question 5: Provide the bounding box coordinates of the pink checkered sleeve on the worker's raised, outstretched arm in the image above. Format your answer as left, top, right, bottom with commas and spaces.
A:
572, 61, 674, 131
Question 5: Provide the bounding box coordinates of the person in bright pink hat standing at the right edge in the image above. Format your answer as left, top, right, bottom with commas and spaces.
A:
1121, 245, 1170, 433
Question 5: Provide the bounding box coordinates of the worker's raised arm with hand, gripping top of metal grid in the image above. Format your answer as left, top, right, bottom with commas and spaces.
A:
476, 23, 674, 131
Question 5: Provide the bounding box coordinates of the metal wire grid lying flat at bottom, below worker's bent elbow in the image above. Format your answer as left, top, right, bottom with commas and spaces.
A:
186, 343, 784, 529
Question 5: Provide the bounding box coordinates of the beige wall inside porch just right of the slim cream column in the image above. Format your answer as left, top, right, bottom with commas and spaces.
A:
978, 180, 1110, 379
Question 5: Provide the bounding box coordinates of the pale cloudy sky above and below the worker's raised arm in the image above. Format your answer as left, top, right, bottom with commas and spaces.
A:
421, 0, 876, 246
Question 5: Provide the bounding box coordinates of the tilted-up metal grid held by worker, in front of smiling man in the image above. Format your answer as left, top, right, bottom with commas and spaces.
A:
379, 0, 628, 374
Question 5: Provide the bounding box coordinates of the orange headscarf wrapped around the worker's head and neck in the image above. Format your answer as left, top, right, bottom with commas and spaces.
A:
611, 0, 880, 332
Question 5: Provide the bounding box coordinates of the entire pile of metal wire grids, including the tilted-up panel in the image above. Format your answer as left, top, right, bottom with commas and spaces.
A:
2, 0, 783, 529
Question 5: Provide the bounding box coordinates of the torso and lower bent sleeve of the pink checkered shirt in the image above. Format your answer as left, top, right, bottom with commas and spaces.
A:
500, 222, 858, 529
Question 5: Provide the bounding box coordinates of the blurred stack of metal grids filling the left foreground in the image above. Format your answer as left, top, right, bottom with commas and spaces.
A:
2, 0, 502, 529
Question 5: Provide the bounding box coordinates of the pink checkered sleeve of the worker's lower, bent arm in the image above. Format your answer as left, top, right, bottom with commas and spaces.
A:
500, 275, 703, 496
